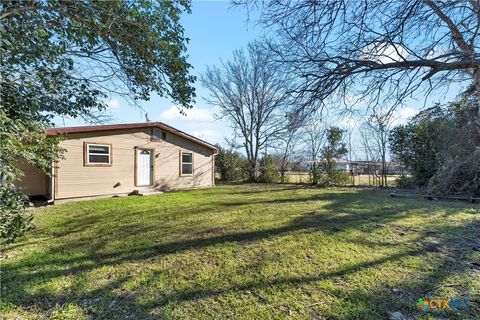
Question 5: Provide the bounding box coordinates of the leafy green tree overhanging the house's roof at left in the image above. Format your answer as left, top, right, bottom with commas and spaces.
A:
0, 0, 195, 240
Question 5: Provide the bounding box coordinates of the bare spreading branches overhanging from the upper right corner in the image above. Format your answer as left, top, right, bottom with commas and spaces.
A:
233, 0, 480, 135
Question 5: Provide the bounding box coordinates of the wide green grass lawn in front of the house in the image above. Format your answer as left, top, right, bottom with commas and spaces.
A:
0, 184, 480, 319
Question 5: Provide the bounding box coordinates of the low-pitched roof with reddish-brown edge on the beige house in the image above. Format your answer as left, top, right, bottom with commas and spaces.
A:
46, 122, 218, 151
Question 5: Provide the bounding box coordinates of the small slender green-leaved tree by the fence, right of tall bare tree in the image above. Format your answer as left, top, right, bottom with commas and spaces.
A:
321, 127, 348, 187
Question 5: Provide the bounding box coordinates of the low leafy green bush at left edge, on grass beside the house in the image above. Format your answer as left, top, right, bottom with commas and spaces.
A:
0, 186, 33, 242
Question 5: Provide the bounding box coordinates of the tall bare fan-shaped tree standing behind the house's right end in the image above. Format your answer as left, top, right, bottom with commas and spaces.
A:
201, 43, 291, 181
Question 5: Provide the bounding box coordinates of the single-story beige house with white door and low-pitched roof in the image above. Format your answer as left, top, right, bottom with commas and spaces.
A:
17, 122, 217, 200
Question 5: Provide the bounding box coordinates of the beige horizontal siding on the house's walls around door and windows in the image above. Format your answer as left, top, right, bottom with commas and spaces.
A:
56, 128, 214, 199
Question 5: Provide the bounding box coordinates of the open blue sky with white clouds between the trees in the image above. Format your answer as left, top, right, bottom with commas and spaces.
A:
55, 1, 468, 159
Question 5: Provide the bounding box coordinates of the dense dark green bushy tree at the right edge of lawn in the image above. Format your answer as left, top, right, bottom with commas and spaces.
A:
390, 88, 480, 196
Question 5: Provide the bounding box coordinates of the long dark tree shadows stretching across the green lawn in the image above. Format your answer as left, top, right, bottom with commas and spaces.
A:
2, 188, 480, 319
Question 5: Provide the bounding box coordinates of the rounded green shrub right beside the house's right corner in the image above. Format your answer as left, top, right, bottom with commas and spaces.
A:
215, 146, 248, 181
